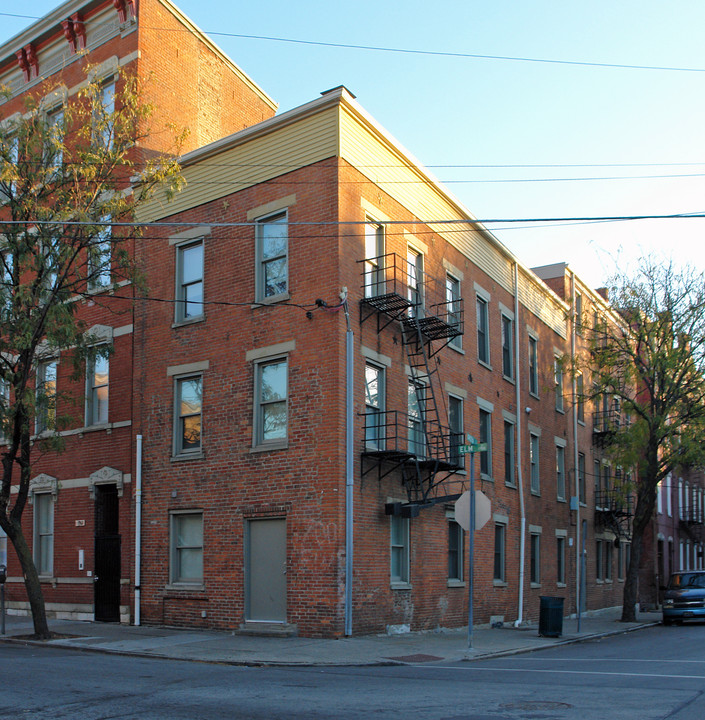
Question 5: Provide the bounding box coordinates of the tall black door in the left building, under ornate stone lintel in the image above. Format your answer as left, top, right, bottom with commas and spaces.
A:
94, 485, 120, 622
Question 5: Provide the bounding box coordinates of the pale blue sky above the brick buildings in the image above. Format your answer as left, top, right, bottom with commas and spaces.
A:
0, 0, 705, 287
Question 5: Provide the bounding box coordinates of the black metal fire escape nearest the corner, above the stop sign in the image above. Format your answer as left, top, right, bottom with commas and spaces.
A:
360, 253, 464, 517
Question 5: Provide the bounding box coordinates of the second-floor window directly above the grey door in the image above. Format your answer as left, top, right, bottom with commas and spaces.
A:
255, 358, 288, 445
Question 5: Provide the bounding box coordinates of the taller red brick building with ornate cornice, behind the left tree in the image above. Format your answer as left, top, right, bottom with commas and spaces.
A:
0, 0, 276, 622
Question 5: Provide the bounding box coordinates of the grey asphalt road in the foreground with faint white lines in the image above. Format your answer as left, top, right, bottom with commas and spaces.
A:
0, 625, 705, 720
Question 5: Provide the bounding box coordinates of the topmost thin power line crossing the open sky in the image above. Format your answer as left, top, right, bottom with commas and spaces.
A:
0, 13, 705, 73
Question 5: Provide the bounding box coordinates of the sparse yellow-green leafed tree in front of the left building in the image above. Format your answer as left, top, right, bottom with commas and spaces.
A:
0, 74, 180, 638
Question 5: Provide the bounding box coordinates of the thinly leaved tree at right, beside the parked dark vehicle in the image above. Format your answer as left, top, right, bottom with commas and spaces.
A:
585, 260, 705, 622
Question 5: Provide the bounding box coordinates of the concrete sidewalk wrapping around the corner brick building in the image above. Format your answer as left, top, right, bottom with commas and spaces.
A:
0, 608, 661, 666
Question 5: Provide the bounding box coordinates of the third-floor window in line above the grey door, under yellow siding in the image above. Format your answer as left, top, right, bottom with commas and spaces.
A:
255, 212, 289, 302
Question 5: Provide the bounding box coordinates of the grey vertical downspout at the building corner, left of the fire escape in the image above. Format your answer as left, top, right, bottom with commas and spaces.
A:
343, 288, 355, 637
